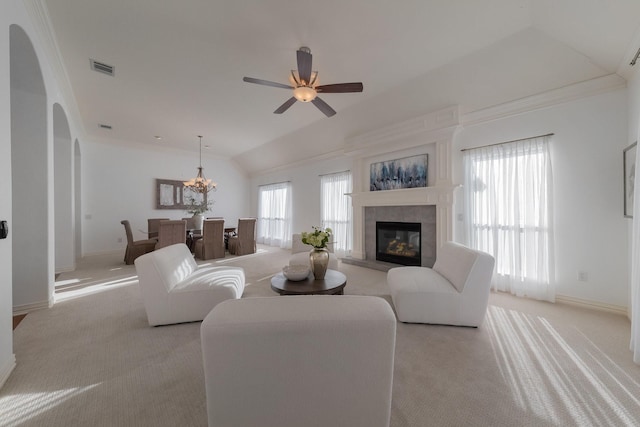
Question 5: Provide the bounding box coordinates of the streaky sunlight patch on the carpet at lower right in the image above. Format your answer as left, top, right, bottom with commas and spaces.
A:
486, 306, 640, 426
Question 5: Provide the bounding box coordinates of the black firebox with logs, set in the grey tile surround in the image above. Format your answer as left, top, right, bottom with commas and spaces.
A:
376, 221, 422, 266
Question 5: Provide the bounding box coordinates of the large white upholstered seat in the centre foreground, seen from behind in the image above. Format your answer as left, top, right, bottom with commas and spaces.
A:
201, 295, 396, 427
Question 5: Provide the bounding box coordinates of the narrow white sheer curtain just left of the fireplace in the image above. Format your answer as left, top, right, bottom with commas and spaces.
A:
320, 171, 353, 257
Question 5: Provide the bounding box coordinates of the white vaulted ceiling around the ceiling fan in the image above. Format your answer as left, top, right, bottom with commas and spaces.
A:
36, 0, 640, 172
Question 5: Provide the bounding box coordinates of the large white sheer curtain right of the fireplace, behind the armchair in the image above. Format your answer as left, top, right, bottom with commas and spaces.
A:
464, 136, 555, 301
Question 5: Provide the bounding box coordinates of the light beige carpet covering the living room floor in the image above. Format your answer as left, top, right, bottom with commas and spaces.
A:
0, 246, 640, 427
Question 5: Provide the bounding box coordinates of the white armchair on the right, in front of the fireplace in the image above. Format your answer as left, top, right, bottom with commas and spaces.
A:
387, 242, 495, 327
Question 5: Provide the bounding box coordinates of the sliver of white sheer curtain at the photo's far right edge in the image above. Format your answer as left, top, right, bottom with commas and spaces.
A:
625, 145, 640, 364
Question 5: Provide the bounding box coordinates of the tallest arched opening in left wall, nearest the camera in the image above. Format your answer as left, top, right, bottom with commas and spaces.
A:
9, 25, 53, 313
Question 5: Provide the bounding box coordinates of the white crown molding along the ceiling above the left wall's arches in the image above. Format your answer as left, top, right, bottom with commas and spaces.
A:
23, 0, 86, 139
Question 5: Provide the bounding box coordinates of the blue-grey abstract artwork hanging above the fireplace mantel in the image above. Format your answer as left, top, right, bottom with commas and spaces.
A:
369, 154, 429, 191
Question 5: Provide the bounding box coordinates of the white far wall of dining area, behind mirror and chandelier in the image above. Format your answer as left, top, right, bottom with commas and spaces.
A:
81, 143, 250, 257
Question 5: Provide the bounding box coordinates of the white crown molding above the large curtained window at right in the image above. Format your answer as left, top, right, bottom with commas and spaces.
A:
461, 74, 627, 126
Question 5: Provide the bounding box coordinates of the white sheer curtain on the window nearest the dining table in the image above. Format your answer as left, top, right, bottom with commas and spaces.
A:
256, 182, 291, 248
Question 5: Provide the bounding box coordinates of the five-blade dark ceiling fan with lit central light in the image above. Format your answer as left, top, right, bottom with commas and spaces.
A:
242, 46, 362, 117
